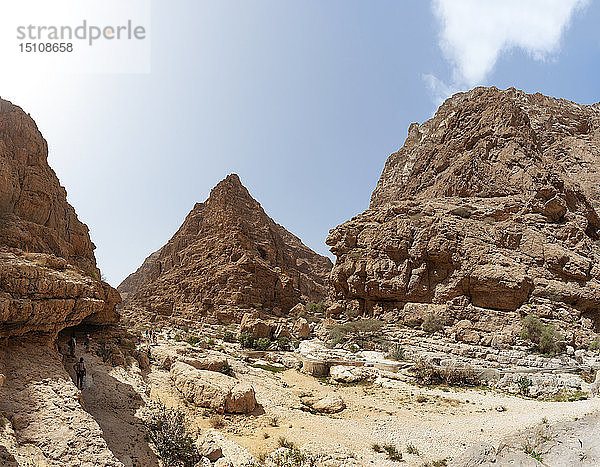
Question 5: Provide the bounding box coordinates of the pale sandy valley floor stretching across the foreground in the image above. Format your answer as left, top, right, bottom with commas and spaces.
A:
149, 350, 600, 466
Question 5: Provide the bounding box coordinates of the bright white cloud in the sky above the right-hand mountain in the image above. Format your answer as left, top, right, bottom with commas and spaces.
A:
424, 0, 588, 98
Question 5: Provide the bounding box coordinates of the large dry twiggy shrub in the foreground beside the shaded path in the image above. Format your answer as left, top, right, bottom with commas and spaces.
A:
144, 403, 198, 466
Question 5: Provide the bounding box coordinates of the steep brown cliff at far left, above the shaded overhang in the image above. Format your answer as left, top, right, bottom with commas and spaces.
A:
0, 99, 120, 337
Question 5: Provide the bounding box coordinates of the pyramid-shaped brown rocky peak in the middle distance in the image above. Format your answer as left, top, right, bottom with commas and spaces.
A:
118, 174, 332, 321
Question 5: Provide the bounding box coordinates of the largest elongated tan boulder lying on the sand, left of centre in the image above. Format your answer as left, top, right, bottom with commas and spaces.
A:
171, 362, 256, 413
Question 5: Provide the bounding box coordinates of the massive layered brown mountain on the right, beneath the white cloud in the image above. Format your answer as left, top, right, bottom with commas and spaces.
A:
327, 88, 600, 344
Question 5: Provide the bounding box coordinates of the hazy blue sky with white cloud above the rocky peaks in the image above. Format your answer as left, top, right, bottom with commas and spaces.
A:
0, 0, 600, 286
